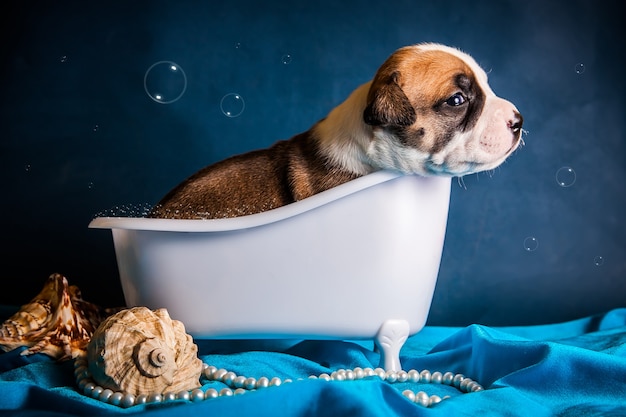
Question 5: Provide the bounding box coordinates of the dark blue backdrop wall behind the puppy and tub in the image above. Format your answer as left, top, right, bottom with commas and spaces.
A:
0, 0, 626, 325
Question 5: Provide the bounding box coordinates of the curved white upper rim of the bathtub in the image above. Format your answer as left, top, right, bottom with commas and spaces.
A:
88, 170, 450, 232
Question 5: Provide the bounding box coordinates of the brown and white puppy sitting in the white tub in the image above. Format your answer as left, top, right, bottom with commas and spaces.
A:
149, 43, 522, 219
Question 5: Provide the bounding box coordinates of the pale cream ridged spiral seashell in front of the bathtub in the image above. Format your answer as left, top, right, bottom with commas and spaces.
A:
87, 307, 202, 395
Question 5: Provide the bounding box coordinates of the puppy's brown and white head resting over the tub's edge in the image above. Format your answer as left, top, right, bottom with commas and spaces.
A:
363, 44, 522, 176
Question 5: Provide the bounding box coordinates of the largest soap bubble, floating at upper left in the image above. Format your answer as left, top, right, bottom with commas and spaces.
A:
143, 61, 187, 104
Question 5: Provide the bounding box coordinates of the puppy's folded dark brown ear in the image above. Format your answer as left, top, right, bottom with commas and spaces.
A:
363, 72, 416, 126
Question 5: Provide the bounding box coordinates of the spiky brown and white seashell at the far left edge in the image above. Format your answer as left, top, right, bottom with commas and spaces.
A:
0, 273, 112, 360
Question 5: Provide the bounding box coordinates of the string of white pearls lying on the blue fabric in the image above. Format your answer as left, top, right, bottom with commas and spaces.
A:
74, 357, 484, 408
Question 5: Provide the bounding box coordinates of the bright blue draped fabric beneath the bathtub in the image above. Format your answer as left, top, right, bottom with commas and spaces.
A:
0, 309, 626, 417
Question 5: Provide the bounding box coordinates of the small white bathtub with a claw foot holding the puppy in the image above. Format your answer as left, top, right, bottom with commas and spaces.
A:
89, 171, 450, 370
